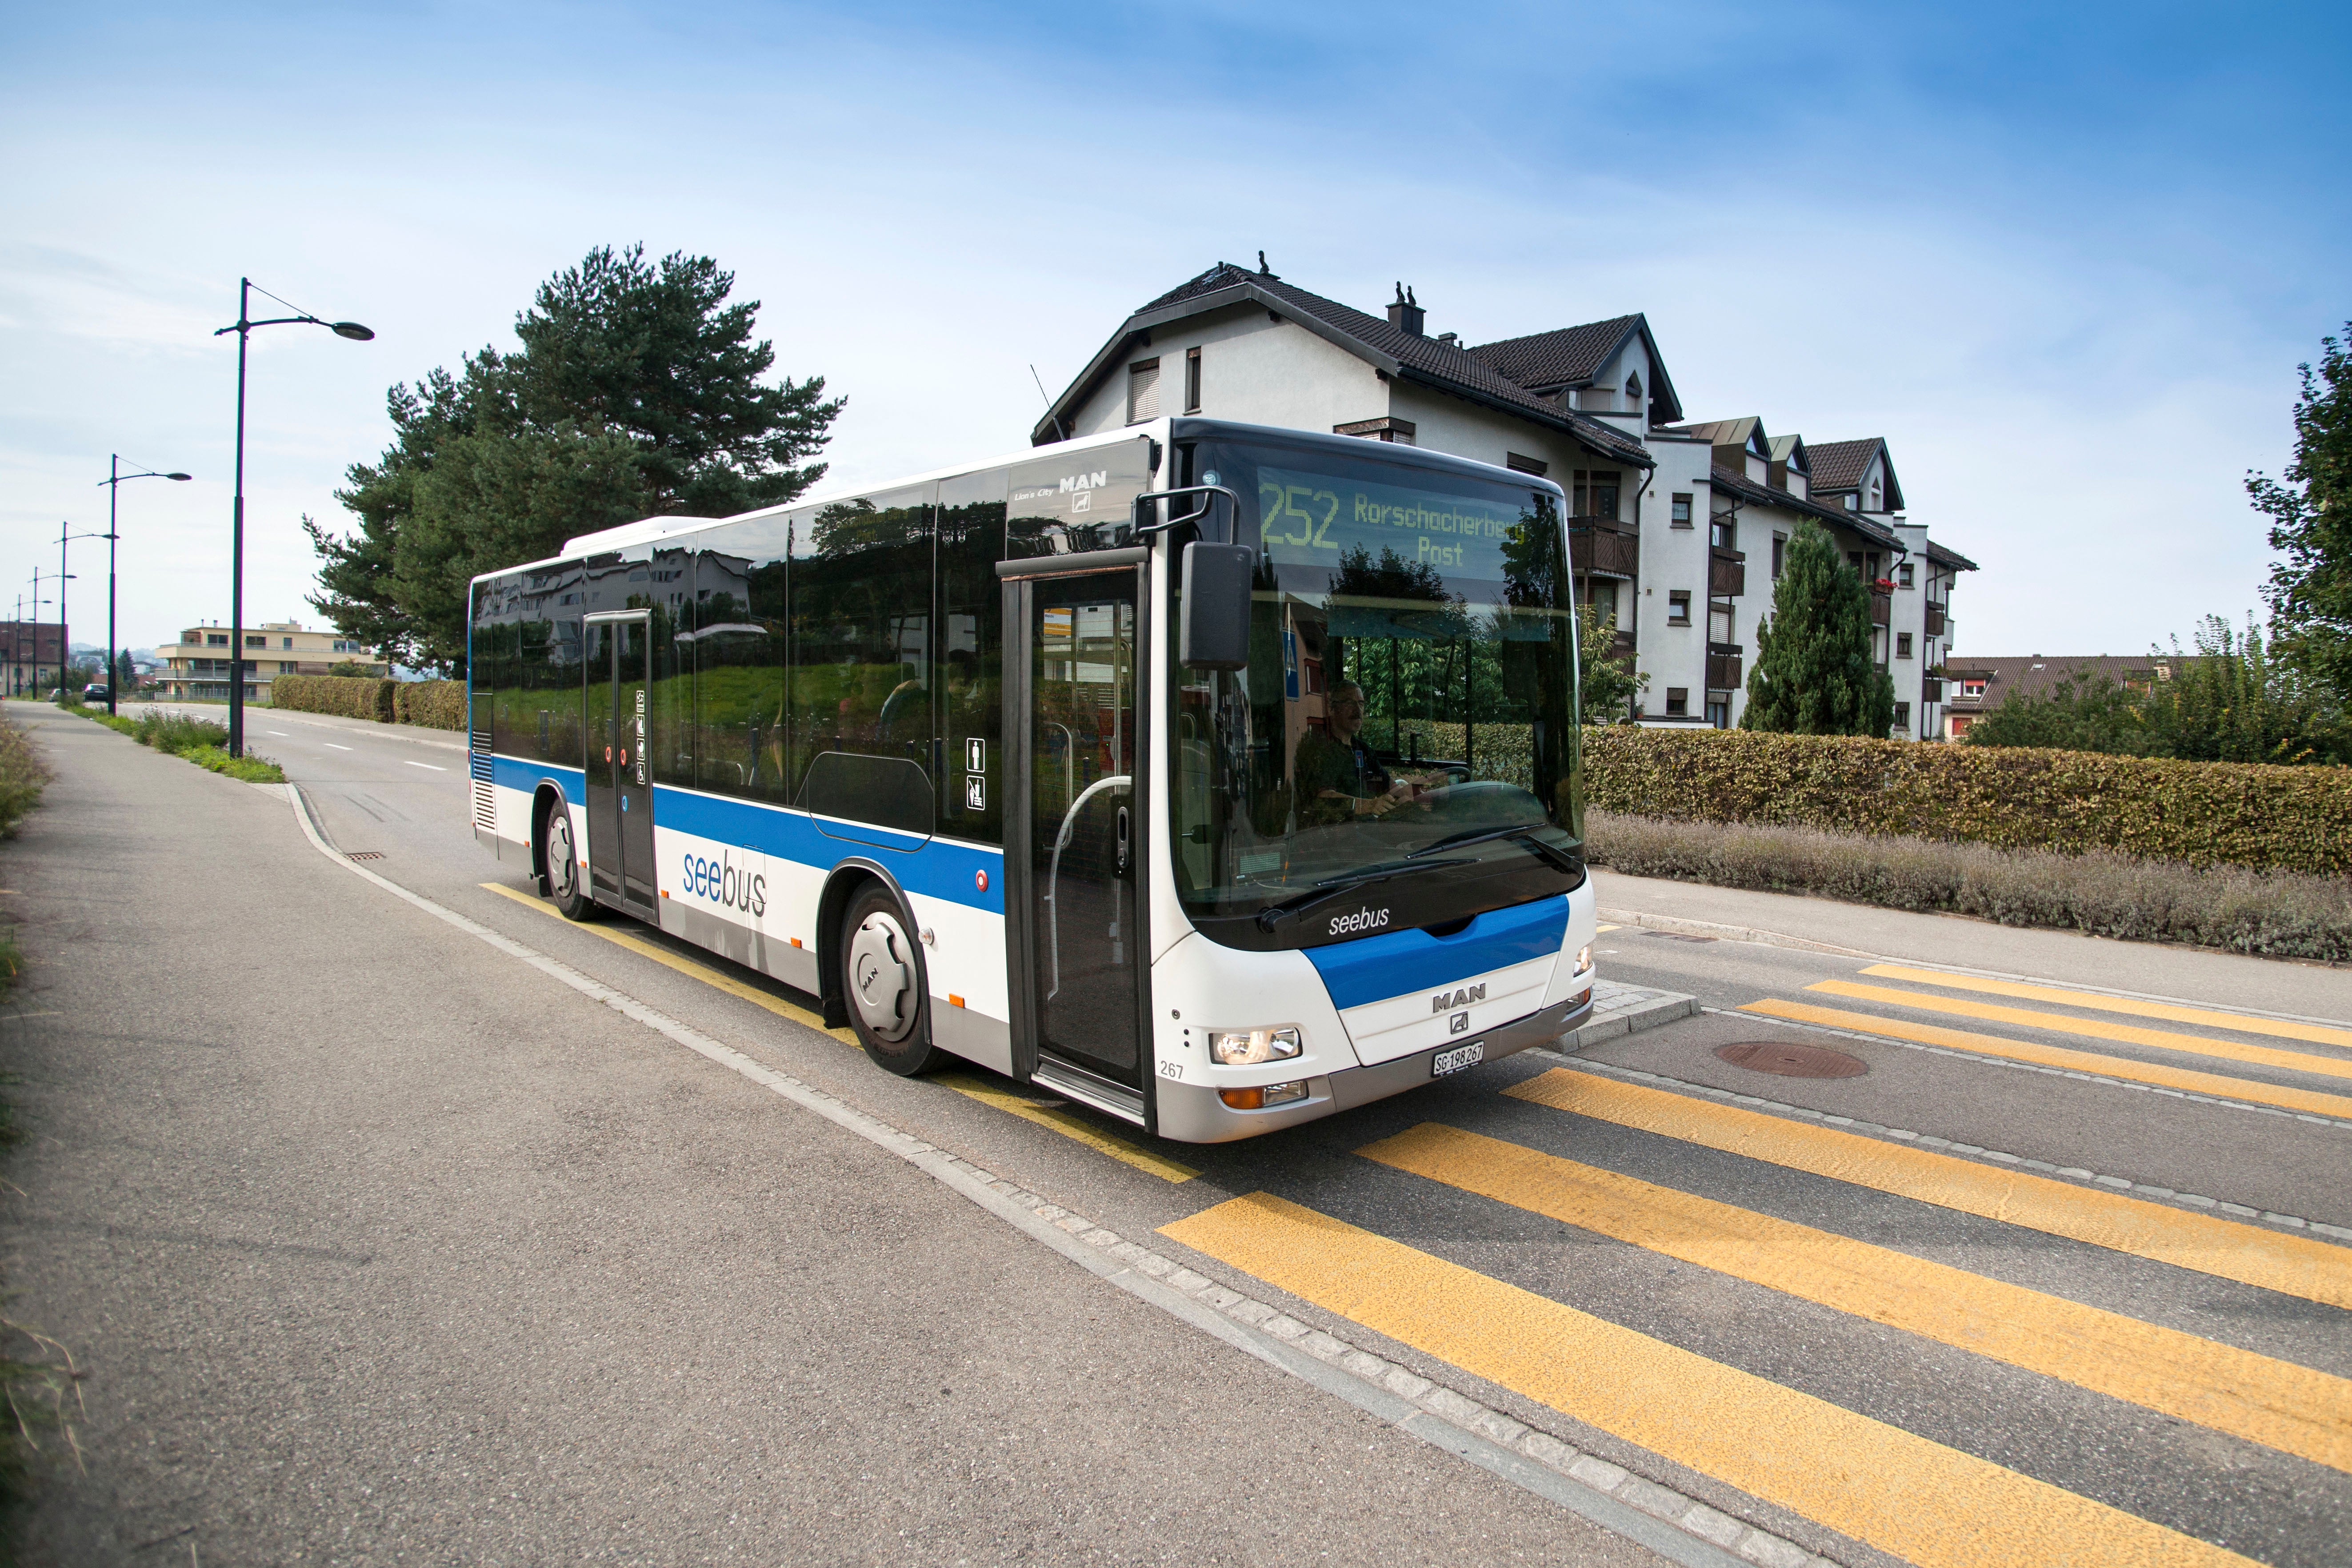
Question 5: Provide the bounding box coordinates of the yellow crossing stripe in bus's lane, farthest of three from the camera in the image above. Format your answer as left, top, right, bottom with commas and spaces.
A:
1503, 1067, 2352, 1309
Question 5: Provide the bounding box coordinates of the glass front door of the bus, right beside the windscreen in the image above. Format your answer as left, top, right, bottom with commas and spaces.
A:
1000, 552, 1150, 1121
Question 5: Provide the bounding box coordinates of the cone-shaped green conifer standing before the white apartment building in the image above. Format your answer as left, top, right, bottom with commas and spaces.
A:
1740, 522, 1896, 736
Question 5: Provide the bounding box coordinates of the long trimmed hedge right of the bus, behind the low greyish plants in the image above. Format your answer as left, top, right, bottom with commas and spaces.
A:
1585, 724, 2352, 877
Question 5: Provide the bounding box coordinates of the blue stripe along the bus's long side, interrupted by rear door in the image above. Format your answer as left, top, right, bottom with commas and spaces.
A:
494, 757, 1004, 914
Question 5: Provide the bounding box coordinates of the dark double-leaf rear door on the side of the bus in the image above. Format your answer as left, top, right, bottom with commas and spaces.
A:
586, 614, 659, 919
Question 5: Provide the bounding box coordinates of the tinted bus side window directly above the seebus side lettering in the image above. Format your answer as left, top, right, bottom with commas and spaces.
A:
694, 517, 790, 802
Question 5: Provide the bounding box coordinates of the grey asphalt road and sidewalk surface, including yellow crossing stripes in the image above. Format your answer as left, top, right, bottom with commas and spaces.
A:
0, 705, 2352, 1566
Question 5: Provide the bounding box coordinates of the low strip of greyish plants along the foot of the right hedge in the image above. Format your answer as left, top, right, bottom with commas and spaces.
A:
1585, 811, 2352, 964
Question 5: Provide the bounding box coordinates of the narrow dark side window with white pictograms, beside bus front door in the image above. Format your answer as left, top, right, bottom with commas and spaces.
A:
932, 468, 1007, 844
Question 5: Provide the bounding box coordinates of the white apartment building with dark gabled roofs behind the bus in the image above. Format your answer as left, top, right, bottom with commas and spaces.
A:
1030, 256, 1976, 741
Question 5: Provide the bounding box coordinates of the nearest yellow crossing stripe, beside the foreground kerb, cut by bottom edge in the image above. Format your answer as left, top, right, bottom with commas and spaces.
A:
1160, 1192, 2248, 1568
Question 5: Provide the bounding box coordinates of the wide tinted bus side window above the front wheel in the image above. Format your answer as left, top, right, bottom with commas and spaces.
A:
788, 484, 936, 834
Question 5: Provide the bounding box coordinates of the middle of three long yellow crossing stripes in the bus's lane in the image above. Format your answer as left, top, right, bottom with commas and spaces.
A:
1357, 1121, 2352, 1472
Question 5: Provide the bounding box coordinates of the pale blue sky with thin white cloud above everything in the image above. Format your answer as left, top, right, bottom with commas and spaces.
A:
0, 0, 2352, 654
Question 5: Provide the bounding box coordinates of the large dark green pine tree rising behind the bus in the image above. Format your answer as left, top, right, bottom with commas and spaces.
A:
304, 244, 842, 674
